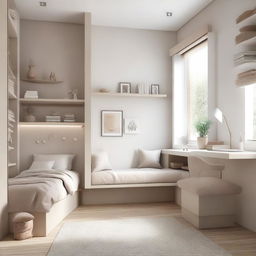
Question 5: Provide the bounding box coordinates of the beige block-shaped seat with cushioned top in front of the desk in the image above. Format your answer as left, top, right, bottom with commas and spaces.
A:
178, 177, 241, 229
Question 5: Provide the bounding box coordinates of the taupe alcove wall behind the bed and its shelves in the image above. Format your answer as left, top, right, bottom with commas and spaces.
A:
20, 20, 84, 183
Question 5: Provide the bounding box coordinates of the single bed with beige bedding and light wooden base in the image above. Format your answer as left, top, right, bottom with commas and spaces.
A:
8, 155, 79, 236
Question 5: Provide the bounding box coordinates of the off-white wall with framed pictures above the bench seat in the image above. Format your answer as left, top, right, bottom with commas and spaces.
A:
92, 26, 176, 168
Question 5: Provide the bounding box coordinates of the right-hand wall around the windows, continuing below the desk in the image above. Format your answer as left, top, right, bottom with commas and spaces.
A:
177, 0, 256, 231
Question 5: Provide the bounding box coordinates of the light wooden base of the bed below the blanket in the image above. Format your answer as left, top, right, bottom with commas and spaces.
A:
9, 191, 79, 236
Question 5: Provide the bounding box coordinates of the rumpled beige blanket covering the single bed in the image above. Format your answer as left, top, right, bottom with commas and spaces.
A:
9, 170, 79, 212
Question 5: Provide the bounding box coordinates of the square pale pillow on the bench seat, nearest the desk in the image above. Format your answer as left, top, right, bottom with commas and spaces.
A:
138, 149, 162, 169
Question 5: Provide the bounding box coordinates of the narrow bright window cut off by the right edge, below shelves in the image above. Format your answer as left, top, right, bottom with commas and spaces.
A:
245, 84, 256, 141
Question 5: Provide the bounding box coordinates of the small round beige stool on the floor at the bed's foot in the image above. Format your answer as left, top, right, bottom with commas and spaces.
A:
13, 212, 34, 240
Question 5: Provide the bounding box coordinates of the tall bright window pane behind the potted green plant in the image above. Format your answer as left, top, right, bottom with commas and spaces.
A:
184, 41, 208, 141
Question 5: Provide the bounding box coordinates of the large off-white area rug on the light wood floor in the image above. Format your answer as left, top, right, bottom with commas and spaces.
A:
48, 217, 231, 256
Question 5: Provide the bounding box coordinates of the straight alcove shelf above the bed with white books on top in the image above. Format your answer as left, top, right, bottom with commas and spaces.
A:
20, 98, 84, 105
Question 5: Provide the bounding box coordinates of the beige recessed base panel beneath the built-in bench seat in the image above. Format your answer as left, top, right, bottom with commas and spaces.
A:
81, 187, 174, 205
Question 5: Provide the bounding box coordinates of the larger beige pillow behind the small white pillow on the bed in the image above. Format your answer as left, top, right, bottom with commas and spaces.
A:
34, 154, 75, 170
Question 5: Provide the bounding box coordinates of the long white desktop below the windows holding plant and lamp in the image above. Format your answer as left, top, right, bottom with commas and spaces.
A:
162, 149, 256, 159
